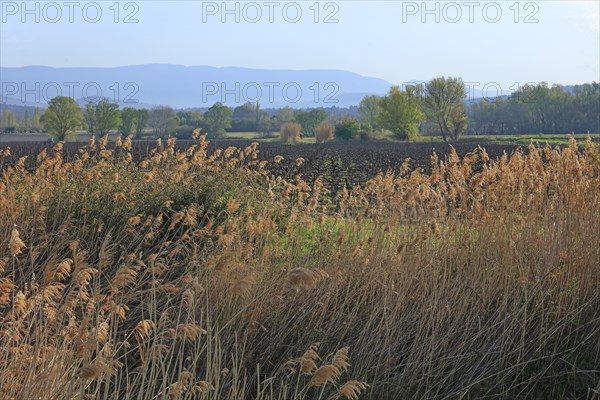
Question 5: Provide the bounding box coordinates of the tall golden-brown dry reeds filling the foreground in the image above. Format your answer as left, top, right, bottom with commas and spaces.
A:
0, 136, 600, 400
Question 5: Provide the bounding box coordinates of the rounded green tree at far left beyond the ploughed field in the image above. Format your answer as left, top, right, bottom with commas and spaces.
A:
40, 96, 83, 141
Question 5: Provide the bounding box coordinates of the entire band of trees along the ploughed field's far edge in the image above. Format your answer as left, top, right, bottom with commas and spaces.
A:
7, 77, 600, 142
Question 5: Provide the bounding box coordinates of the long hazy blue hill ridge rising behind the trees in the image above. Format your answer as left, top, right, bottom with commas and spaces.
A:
0, 64, 392, 108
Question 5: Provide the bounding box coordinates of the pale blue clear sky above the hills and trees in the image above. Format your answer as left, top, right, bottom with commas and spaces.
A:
0, 0, 600, 90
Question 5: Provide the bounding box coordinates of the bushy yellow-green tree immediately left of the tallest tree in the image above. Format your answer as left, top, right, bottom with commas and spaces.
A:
376, 86, 425, 140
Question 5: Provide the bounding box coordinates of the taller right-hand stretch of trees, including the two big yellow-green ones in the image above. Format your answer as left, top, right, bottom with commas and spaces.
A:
358, 78, 600, 141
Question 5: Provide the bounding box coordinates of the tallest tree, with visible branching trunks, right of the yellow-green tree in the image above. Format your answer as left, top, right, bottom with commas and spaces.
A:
424, 77, 467, 141
